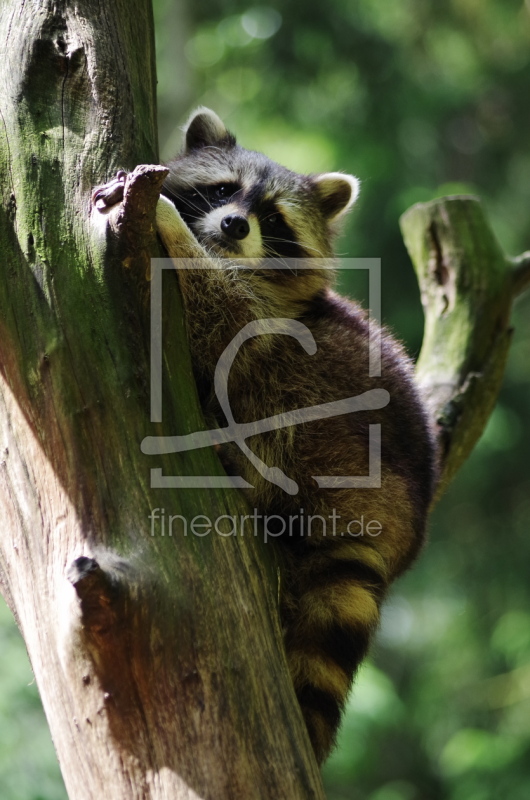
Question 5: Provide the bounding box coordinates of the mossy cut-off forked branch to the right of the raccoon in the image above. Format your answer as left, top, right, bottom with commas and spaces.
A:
401, 196, 530, 501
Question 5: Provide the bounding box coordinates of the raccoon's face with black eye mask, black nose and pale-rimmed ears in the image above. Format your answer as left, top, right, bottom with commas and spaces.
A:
162, 108, 359, 260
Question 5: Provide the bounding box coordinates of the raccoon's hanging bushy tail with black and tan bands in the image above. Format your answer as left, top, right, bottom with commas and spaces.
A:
282, 541, 387, 764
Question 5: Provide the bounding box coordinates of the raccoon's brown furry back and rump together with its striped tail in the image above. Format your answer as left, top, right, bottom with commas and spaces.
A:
211, 293, 435, 761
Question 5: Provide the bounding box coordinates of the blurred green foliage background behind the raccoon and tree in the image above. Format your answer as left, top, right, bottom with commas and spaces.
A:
0, 0, 530, 800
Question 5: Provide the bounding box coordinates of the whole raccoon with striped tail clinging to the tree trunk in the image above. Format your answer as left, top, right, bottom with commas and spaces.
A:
95, 108, 436, 763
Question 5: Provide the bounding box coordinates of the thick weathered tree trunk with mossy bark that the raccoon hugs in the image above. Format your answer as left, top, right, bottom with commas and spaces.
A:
0, 0, 322, 800
